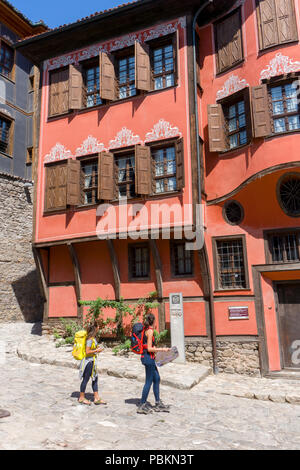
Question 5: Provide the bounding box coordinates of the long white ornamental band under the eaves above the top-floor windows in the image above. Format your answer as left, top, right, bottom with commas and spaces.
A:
44, 17, 186, 70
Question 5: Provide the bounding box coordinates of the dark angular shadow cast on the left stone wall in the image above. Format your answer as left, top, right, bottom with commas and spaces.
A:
12, 270, 44, 323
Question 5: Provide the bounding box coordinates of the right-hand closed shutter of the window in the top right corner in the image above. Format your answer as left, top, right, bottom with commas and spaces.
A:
275, 0, 298, 44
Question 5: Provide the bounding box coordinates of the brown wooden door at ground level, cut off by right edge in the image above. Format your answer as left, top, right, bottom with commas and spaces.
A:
277, 282, 300, 369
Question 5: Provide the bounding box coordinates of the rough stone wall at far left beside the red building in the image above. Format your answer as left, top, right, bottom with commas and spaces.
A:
0, 173, 43, 322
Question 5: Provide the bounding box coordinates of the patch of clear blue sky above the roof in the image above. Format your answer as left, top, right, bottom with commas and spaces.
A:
9, 0, 130, 28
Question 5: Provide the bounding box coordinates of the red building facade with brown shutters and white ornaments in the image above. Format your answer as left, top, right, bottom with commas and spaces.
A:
18, 0, 300, 375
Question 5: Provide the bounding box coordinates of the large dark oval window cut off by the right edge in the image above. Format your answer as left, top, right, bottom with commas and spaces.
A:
279, 174, 300, 217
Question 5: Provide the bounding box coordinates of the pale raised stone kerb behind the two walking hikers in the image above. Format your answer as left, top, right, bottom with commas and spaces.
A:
16, 337, 212, 390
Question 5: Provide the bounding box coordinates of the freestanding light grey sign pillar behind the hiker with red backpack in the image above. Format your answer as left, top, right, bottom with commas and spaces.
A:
169, 293, 185, 363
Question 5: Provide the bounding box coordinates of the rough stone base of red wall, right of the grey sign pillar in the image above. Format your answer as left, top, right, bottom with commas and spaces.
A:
186, 338, 261, 377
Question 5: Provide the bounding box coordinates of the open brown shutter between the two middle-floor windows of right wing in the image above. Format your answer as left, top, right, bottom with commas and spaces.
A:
251, 85, 272, 137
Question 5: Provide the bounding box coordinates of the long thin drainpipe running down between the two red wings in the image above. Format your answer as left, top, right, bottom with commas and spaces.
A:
193, 0, 218, 374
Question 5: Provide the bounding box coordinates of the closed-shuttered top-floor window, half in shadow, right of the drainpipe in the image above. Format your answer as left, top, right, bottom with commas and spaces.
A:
215, 9, 243, 73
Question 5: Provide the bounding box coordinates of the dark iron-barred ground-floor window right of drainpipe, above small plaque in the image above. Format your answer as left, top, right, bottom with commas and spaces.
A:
217, 239, 247, 289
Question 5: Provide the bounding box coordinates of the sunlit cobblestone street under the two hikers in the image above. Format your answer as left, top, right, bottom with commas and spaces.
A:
0, 323, 300, 450
